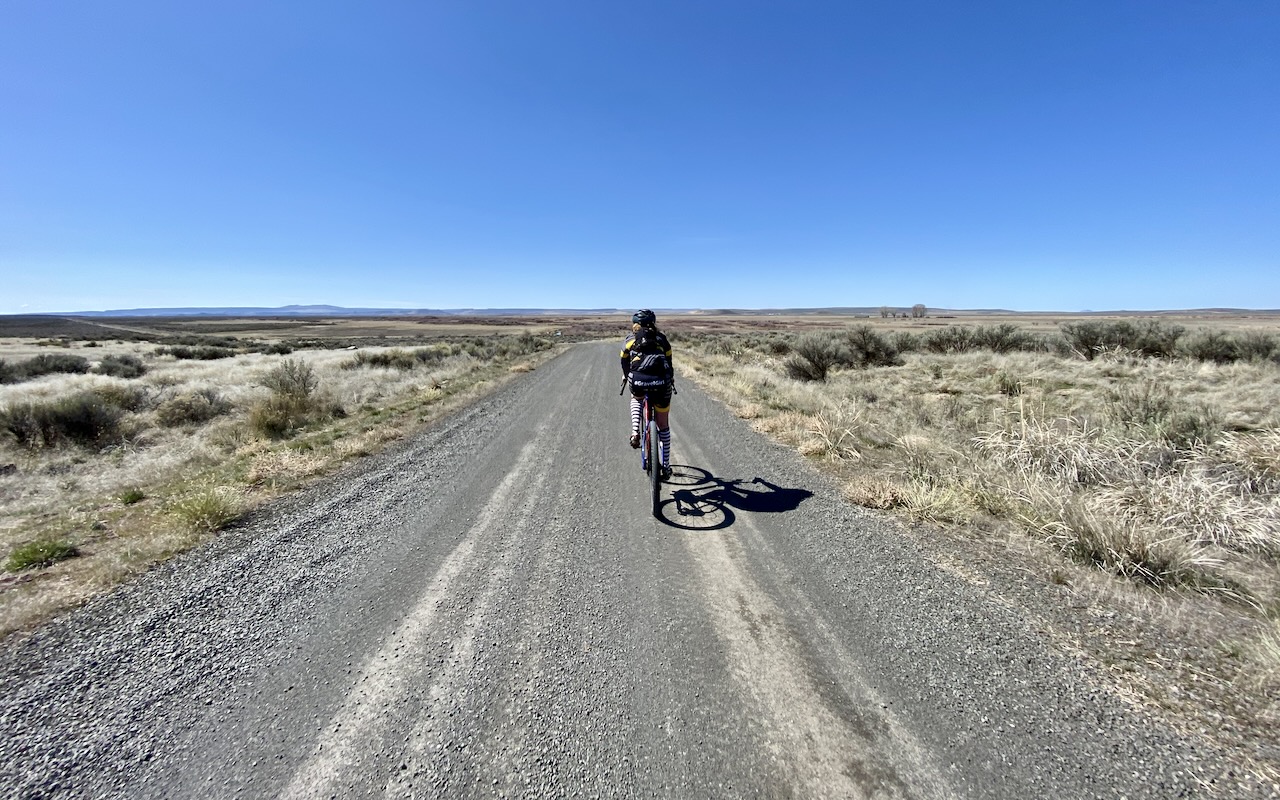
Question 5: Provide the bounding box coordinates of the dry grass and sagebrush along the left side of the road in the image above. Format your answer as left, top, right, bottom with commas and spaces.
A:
0, 334, 554, 636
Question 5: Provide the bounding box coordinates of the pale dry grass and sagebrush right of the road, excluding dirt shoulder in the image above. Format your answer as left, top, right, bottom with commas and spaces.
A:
677, 320, 1280, 742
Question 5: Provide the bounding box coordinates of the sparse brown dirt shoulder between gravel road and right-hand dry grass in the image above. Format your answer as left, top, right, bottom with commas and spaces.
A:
902, 521, 1280, 796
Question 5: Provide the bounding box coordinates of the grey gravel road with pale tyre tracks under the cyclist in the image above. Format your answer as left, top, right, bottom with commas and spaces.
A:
0, 344, 1244, 799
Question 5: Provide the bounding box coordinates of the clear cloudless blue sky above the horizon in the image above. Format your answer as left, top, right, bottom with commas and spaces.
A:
0, 0, 1280, 314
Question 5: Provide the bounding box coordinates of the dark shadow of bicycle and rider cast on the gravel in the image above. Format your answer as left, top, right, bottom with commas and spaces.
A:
658, 463, 813, 530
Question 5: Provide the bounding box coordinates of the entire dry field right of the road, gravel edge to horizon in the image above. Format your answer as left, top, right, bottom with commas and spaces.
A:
673, 315, 1280, 776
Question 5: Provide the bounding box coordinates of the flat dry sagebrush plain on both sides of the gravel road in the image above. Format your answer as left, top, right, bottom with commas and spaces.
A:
0, 312, 1280, 796
